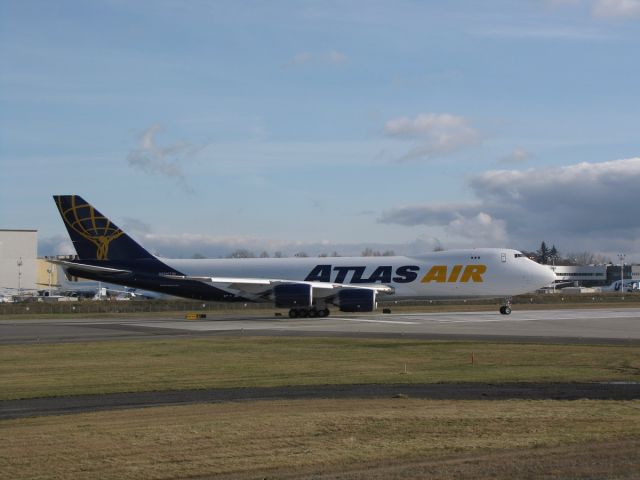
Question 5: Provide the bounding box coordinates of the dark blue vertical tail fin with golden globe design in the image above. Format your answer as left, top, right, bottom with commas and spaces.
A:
53, 195, 155, 260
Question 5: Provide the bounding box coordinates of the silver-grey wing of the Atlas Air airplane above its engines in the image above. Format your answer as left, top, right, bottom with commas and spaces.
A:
161, 275, 394, 301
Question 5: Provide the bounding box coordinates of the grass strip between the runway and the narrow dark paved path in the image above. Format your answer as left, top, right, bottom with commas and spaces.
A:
0, 337, 640, 399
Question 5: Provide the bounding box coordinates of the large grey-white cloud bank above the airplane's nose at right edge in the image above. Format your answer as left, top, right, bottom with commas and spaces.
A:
379, 157, 640, 254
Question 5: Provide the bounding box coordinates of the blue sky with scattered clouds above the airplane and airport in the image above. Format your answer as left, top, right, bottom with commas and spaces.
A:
0, 0, 640, 263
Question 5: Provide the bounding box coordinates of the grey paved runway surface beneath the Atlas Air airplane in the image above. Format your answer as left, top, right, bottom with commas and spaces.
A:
0, 308, 640, 344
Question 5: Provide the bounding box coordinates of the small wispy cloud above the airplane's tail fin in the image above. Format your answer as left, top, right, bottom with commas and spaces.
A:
127, 125, 199, 191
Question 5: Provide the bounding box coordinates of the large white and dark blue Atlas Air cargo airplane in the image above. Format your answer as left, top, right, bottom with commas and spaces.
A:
49, 195, 555, 318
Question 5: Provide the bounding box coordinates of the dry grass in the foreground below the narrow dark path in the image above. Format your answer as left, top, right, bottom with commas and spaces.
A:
0, 399, 640, 479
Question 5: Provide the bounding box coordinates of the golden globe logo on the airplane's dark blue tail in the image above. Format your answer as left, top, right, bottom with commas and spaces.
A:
58, 196, 124, 260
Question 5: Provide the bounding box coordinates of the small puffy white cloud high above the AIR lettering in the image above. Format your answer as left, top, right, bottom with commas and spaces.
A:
384, 113, 482, 162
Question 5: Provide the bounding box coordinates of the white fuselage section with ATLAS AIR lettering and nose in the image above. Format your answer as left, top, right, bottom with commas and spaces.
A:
161, 248, 555, 298
